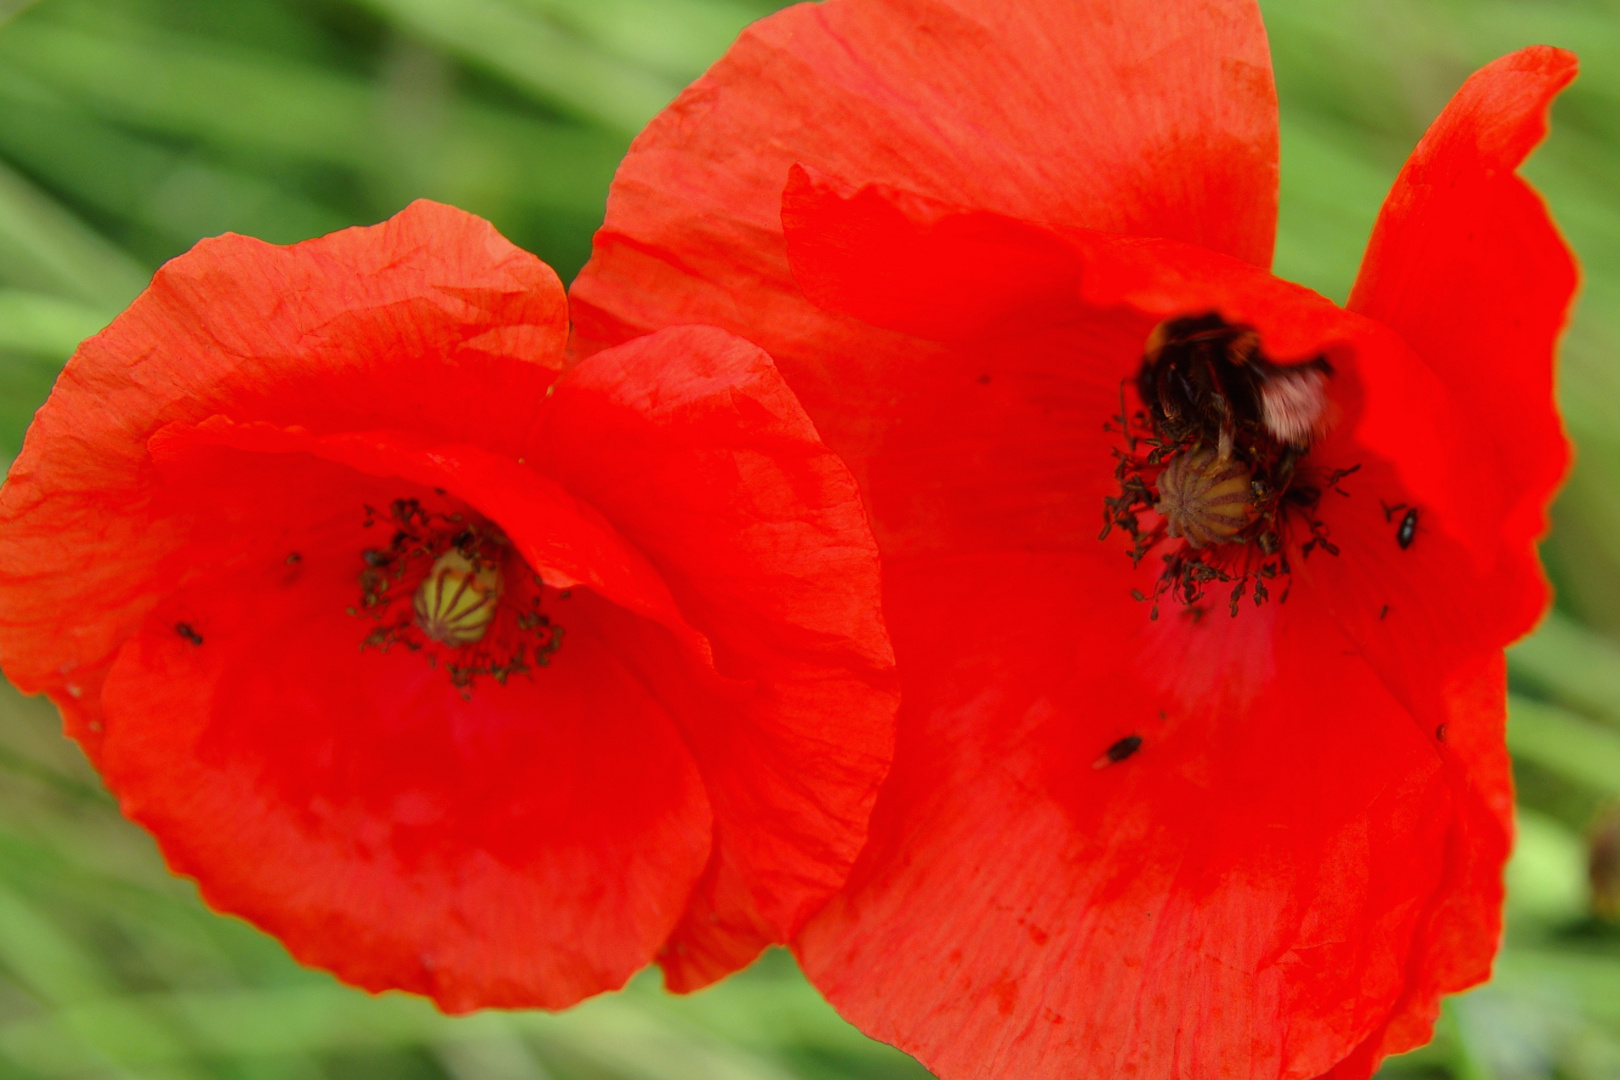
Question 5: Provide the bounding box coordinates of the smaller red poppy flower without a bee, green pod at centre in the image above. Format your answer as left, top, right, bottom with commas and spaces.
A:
0, 202, 896, 1010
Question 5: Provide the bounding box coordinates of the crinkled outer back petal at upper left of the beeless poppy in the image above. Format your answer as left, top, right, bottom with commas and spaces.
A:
0, 201, 565, 746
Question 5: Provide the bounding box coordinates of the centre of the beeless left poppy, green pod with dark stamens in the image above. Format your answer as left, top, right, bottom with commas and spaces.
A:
348, 499, 567, 696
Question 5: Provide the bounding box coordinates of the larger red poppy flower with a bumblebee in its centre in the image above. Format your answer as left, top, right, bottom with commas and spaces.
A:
572, 0, 1575, 1080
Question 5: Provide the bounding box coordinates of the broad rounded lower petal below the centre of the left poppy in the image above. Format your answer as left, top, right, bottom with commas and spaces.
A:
100, 459, 711, 1012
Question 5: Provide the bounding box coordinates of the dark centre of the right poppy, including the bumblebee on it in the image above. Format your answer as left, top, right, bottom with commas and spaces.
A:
1102, 316, 1359, 619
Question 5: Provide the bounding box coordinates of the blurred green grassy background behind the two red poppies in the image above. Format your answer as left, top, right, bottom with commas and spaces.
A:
0, 0, 1620, 1080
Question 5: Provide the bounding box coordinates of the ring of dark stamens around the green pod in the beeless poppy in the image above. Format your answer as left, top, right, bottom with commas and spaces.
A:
348, 499, 562, 698
